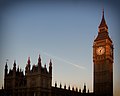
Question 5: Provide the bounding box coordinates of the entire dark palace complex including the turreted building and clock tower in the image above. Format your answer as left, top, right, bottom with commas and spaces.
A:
0, 10, 113, 96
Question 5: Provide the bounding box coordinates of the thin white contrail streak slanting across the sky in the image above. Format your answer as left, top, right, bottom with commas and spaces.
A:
43, 52, 86, 69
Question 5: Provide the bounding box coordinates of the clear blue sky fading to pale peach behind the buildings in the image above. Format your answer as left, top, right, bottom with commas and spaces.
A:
0, 0, 120, 96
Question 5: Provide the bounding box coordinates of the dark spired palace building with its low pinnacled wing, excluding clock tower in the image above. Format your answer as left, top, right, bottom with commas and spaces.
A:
4, 55, 93, 96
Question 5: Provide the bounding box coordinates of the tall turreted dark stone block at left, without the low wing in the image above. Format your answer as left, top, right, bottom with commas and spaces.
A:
4, 55, 52, 96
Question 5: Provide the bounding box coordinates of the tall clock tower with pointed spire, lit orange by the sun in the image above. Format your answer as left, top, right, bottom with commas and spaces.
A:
93, 10, 113, 96
